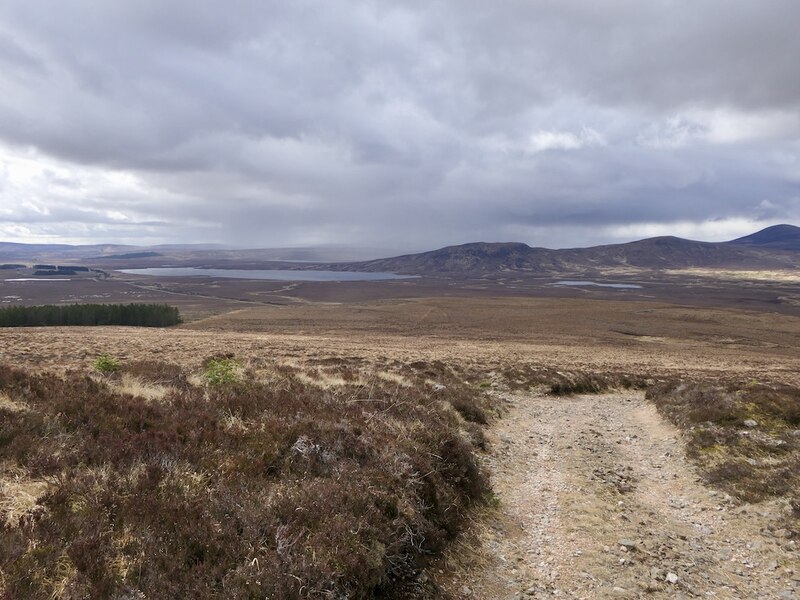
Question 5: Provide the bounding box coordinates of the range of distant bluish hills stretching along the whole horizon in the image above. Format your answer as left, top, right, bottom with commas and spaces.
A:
0, 225, 800, 277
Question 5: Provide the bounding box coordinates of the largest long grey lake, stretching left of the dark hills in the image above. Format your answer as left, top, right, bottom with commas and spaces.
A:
120, 267, 417, 281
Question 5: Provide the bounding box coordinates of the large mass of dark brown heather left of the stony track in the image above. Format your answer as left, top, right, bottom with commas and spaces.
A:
0, 363, 488, 599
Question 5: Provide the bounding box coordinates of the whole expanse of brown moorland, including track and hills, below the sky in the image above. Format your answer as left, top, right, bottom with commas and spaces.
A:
0, 228, 800, 598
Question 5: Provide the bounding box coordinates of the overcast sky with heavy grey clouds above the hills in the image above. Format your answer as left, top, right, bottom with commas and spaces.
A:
0, 0, 800, 251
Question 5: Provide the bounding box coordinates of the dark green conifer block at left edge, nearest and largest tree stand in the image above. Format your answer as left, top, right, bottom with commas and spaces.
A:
0, 304, 182, 327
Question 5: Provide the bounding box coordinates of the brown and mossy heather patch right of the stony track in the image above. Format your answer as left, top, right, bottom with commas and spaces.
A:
647, 382, 800, 518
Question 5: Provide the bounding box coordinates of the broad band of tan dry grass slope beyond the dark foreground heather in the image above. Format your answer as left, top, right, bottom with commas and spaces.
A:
0, 293, 800, 384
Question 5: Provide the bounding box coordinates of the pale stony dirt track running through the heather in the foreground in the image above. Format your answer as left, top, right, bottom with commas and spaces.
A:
446, 393, 800, 599
